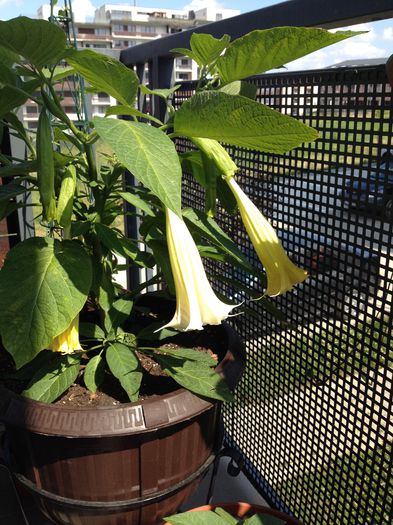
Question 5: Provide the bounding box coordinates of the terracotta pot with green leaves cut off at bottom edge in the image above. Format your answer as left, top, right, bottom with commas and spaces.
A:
164, 502, 302, 525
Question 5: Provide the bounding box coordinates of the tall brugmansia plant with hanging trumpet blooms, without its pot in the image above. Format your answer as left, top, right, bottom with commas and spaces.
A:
0, 17, 360, 402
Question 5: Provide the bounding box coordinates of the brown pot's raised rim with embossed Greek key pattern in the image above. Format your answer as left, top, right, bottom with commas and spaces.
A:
0, 324, 244, 438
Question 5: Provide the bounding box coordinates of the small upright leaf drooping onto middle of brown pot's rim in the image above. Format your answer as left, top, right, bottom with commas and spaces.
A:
105, 343, 142, 401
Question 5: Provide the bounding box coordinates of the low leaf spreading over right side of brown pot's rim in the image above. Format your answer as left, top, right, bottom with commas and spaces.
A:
154, 354, 233, 401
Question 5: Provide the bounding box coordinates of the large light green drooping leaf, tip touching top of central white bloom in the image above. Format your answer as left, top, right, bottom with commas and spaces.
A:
93, 117, 182, 215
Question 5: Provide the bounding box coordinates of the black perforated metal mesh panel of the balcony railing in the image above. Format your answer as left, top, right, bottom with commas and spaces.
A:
175, 67, 393, 525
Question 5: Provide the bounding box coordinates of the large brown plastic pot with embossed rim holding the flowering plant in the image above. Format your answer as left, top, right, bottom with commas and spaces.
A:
0, 312, 244, 525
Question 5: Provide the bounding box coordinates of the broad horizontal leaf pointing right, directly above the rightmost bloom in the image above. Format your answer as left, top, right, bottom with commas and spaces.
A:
174, 91, 318, 153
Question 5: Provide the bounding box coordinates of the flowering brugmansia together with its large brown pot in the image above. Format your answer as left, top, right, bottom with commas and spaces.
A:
0, 17, 360, 525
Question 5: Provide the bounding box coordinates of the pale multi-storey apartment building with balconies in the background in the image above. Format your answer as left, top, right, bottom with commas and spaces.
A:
24, 2, 240, 128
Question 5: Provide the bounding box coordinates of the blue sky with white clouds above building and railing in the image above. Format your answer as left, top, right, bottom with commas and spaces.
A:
0, 0, 393, 70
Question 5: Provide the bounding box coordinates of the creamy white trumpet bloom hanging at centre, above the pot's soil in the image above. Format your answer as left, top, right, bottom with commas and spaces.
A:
163, 208, 234, 330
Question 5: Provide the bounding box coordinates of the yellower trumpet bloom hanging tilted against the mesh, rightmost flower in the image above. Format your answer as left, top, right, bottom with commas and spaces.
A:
226, 177, 307, 296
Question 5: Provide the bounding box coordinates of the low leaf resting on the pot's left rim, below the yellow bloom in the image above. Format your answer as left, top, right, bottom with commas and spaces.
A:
22, 354, 80, 403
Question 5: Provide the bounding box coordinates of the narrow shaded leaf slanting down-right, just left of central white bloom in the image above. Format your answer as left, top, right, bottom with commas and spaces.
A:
94, 223, 154, 268
